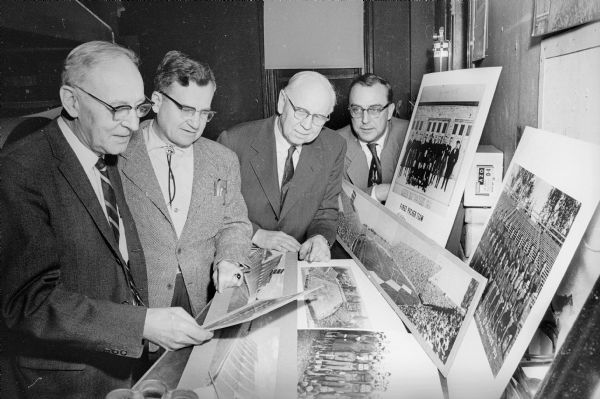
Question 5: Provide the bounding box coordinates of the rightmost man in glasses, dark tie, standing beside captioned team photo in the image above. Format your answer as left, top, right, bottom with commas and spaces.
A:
337, 73, 408, 202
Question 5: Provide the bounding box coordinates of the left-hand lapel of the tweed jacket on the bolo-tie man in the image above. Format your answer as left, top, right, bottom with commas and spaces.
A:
119, 130, 173, 226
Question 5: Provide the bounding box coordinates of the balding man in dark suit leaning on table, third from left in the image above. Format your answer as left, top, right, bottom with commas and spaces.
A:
219, 71, 346, 261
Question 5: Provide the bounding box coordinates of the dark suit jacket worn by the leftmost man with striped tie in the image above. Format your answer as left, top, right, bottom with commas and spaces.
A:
0, 121, 148, 398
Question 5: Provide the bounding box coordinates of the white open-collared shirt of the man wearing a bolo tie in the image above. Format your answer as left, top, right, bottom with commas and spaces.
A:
142, 121, 194, 238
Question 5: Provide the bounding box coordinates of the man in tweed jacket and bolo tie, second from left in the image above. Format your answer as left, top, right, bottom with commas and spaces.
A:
119, 51, 251, 332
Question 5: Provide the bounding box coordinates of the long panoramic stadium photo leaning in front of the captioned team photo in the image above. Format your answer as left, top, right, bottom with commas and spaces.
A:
338, 181, 486, 375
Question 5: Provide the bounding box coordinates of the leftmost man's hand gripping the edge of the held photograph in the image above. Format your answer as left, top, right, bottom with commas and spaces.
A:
143, 308, 213, 351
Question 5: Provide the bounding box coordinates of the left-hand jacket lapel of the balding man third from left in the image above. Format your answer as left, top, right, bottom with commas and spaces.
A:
250, 118, 289, 215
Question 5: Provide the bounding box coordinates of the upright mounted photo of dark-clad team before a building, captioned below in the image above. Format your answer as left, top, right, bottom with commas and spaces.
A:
386, 67, 501, 246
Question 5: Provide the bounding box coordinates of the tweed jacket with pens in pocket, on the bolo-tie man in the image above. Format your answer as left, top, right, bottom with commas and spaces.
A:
119, 122, 251, 315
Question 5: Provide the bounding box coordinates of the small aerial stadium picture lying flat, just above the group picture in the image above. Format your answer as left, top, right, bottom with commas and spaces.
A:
301, 266, 369, 329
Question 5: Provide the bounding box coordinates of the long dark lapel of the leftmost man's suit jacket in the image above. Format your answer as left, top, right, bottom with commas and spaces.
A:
48, 122, 123, 260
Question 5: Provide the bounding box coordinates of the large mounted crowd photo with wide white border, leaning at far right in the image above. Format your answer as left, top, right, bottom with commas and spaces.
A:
470, 127, 600, 392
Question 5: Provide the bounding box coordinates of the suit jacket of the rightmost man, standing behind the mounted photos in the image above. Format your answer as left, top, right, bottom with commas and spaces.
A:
337, 118, 408, 193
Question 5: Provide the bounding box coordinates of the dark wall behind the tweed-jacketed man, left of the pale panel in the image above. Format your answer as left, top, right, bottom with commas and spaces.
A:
117, 1, 262, 139
